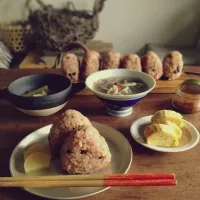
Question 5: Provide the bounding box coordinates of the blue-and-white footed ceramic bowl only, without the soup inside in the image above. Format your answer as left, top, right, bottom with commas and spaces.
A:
85, 69, 156, 117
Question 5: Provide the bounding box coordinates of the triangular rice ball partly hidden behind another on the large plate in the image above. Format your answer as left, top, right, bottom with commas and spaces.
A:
48, 110, 91, 157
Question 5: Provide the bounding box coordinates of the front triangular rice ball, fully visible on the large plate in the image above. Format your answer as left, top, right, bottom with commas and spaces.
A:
61, 126, 111, 174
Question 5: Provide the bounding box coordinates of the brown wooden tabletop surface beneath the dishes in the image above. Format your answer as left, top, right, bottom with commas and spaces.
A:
0, 67, 200, 200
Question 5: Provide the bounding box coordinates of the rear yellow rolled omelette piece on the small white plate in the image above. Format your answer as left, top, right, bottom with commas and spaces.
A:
151, 110, 183, 128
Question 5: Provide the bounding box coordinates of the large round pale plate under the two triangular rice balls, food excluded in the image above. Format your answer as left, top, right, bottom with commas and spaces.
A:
10, 122, 132, 199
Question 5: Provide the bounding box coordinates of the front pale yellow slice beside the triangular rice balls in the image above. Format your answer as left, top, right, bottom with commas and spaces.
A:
24, 152, 50, 174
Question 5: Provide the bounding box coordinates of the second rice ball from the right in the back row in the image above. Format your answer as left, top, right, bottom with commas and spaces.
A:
142, 51, 163, 80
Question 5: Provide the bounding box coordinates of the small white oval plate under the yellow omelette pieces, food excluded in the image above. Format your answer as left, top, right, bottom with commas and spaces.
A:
130, 115, 199, 152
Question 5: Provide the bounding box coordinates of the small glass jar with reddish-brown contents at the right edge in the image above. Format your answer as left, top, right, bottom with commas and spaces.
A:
172, 79, 200, 113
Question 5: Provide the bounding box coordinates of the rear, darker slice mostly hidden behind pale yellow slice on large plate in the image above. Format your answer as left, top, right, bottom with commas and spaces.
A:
24, 143, 51, 160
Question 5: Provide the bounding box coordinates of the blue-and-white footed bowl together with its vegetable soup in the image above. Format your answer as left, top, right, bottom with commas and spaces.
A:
86, 69, 156, 117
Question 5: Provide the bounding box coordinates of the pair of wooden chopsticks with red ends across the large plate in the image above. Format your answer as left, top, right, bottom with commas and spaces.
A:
0, 174, 177, 188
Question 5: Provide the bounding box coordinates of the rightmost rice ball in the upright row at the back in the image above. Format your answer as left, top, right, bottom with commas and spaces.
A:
163, 51, 183, 80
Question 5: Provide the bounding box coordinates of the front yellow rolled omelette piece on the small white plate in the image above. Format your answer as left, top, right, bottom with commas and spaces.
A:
144, 124, 179, 147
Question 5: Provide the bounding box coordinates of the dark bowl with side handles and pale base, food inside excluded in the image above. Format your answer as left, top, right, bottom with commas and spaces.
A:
0, 74, 85, 116
